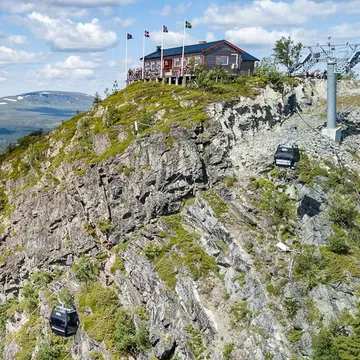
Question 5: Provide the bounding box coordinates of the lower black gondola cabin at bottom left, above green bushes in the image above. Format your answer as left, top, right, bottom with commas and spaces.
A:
50, 306, 79, 337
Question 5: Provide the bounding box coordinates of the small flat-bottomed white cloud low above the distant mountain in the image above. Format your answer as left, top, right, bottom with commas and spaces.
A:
27, 64, 94, 80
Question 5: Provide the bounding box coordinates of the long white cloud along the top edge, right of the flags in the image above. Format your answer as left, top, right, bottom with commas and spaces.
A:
193, 0, 342, 28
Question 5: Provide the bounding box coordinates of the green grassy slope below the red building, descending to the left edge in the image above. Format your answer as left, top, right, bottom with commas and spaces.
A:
0, 79, 264, 197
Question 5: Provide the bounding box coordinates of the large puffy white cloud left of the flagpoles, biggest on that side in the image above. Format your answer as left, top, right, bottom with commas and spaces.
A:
27, 12, 117, 51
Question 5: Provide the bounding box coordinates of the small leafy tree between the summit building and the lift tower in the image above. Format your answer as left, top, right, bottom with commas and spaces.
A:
273, 36, 303, 75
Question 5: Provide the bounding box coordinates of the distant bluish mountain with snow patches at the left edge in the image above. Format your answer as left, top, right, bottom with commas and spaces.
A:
0, 91, 94, 149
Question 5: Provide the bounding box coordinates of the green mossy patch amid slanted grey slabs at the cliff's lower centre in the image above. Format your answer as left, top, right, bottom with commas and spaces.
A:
152, 214, 218, 289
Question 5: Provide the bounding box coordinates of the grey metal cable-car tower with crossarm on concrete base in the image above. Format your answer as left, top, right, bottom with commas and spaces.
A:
294, 37, 360, 142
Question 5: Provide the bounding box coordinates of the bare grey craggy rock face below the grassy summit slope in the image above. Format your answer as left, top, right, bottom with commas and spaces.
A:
0, 79, 359, 360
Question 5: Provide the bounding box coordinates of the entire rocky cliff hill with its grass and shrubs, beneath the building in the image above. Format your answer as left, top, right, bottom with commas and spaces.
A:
0, 82, 360, 360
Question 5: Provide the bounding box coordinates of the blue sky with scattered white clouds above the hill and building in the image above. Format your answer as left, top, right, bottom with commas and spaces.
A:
0, 0, 360, 96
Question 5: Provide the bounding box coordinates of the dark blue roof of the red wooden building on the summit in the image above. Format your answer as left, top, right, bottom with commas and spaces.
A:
140, 40, 260, 61
